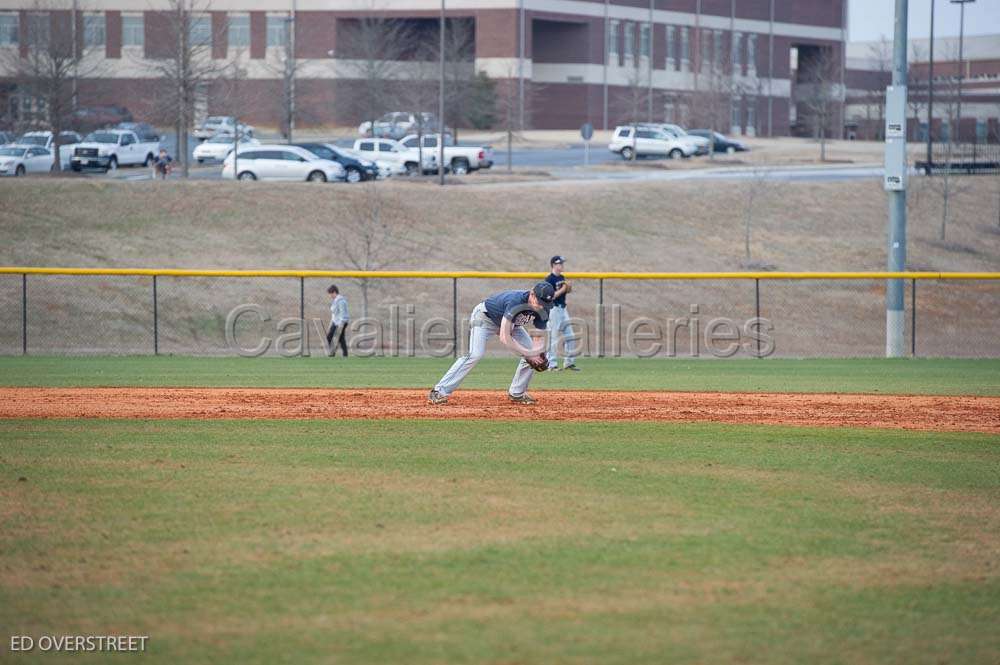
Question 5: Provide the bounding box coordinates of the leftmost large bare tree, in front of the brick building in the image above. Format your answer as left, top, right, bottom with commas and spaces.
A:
0, 1, 104, 171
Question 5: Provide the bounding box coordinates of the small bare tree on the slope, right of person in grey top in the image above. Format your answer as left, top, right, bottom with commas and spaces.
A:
335, 182, 402, 317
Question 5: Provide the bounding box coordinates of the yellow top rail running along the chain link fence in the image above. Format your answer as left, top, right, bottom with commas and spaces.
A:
0, 266, 1000, 280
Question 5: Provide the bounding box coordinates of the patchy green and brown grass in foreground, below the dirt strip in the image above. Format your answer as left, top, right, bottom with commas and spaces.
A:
0, 420, 1000, 665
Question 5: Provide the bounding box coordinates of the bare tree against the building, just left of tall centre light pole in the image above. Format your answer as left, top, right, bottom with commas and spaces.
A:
336, 6, 418, 137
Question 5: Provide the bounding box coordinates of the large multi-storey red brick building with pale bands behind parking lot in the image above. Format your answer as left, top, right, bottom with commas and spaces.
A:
0, 0, 847, 135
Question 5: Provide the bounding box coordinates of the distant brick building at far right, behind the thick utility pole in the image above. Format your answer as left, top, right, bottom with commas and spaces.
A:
845, 35, 1000, 143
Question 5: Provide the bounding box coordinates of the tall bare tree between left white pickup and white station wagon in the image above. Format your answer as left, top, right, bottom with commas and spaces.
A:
143, 0, 233, 178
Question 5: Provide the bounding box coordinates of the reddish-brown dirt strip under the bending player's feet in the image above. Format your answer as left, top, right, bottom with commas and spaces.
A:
0, 388, 1000, 434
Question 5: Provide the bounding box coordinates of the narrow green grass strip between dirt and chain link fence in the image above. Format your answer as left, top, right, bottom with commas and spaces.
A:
0, 356, 1000, 395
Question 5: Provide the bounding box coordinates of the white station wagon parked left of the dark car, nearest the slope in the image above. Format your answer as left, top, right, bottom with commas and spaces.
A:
222, 143, 345, 182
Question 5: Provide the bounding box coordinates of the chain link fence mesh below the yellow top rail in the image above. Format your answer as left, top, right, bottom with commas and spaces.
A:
0, 273, 1000, 358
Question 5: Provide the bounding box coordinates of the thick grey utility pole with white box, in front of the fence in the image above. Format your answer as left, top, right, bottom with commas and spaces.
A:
883, 0, 909, 358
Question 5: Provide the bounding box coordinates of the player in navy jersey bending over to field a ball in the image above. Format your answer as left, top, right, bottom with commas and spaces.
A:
427, 282, 555, 404
